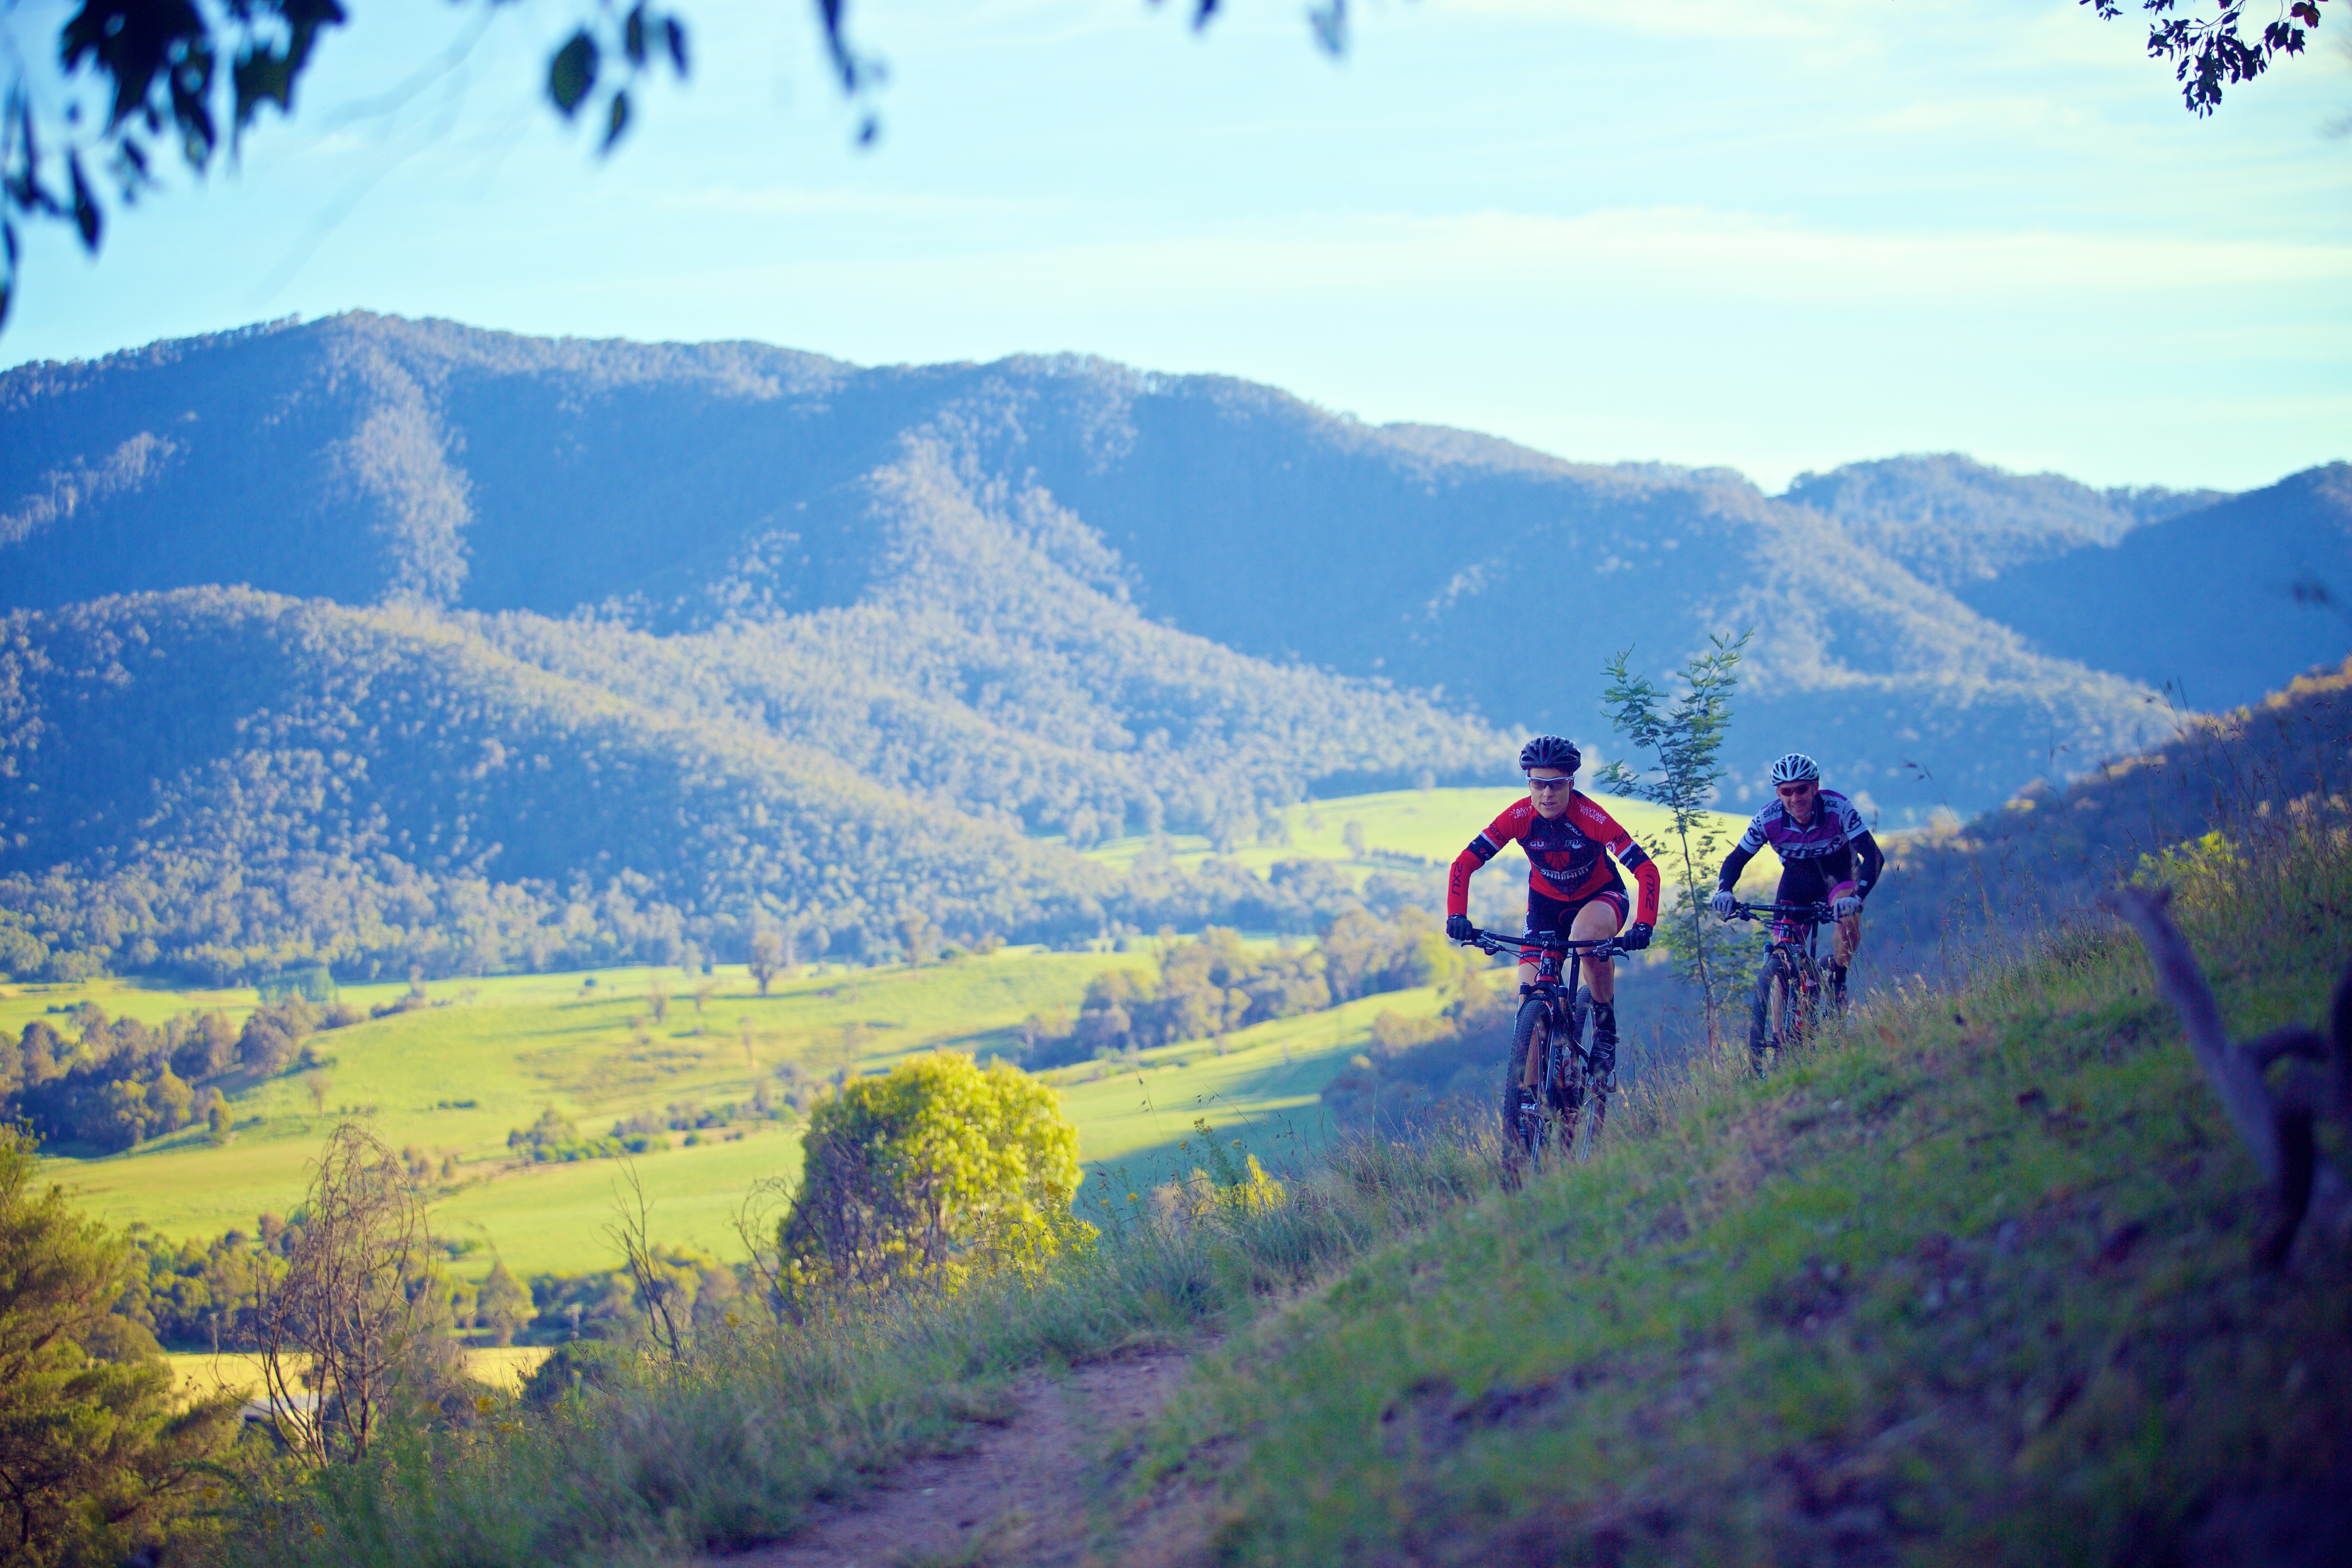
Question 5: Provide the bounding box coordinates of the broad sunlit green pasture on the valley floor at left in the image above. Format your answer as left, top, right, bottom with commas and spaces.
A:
37, 947, 1145, 1272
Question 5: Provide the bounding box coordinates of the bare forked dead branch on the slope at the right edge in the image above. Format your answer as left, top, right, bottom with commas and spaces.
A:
2100, 886, 2352, 1270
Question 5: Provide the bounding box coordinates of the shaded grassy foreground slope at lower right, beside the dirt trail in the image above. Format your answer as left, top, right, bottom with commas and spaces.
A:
1150, 827, 2352, 1563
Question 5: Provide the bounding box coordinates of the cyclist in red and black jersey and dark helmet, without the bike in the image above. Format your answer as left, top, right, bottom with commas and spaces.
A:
1446, 736, 1658, 1072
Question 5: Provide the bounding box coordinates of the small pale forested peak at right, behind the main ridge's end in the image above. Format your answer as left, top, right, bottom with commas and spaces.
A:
1780, 451, 2227, 588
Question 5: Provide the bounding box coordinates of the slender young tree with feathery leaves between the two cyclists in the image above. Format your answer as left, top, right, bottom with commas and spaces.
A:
1597, 633, 1755, 1049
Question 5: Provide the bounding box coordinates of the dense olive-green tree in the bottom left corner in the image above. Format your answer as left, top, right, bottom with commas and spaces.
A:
0, 1126, 238, 1563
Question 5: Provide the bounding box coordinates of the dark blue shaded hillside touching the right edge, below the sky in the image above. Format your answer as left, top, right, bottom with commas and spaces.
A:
1959, 463, 2352, 710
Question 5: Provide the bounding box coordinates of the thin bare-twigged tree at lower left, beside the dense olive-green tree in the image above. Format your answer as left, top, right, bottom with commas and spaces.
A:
259, 1121, 430, 1465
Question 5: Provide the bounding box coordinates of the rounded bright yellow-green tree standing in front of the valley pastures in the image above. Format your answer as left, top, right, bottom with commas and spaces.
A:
776, 1051, 1089, 1316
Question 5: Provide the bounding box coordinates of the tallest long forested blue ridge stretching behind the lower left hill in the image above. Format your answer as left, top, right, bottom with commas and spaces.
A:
0, 315, 2239, 823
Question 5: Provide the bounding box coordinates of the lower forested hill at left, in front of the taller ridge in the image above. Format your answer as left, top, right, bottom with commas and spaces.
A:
0, 590, 1108, 976
